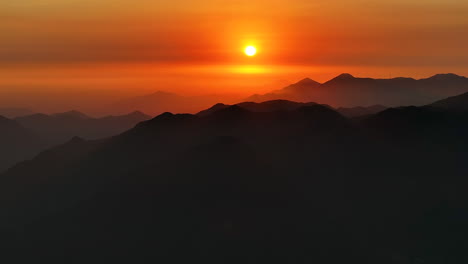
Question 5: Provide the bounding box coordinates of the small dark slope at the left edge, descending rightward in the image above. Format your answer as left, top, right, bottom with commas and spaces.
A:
0, 116, 46, 172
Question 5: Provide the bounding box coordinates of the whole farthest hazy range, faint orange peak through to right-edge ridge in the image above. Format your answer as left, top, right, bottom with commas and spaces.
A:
74, 74, 468, 116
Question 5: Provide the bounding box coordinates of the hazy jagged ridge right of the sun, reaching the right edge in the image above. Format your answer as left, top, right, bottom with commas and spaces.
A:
247, 74, 468, 107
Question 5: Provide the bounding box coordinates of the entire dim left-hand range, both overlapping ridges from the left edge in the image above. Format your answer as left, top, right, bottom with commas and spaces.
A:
0, 111, 151, 172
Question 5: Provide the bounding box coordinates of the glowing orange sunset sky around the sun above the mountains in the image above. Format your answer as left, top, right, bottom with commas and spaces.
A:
0, 0, 468, 111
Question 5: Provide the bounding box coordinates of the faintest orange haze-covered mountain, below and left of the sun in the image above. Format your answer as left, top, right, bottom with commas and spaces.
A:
110, 91, 239, 116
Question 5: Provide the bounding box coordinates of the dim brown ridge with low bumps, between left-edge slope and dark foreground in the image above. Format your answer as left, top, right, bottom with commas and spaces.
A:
15, 111, 151, 144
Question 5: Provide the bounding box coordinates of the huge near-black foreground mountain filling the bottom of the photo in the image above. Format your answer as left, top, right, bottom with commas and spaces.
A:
0, 100, 468, 264
